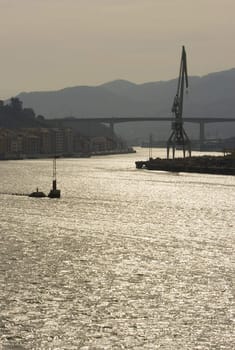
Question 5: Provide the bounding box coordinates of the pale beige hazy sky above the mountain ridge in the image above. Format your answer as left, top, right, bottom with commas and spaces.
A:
0, 0, 235, 98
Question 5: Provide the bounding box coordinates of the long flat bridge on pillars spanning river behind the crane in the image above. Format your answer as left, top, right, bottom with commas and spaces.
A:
52, 116, 235, 145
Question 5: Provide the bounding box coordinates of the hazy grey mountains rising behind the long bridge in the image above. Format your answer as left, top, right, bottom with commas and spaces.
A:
13, 68, 235, 142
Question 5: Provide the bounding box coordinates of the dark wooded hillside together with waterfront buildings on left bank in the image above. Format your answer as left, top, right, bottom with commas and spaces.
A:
0, 98, 130, 160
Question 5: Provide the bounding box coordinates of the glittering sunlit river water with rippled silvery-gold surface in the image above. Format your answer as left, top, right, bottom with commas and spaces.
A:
0, 149, 235, 350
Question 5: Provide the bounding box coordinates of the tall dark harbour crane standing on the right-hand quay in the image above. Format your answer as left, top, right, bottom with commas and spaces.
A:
167, 46, 191, 159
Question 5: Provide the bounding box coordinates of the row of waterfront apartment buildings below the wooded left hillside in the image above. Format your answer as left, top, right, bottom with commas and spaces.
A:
0, 128, 117, 159
